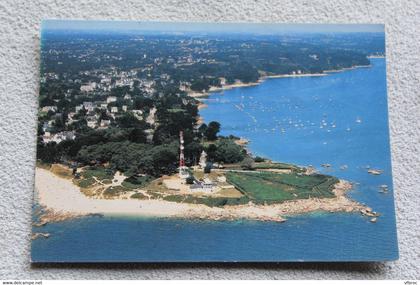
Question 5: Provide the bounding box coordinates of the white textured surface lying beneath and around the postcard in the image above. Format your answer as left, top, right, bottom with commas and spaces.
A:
0, 0, 420, 279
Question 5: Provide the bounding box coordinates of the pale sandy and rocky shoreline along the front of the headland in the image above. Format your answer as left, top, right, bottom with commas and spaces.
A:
34, 167, 373, 226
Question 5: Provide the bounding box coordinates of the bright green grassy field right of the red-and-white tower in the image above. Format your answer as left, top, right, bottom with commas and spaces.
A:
226, 171, 338, 204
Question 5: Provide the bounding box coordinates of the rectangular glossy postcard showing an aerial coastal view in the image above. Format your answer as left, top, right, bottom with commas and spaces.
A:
31, 20, 398, 263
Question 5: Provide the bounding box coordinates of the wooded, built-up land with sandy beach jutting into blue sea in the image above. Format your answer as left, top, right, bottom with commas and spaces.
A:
36, 31, 375, 225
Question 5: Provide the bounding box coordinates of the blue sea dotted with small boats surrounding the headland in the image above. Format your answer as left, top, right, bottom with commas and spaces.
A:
32, 58, 398, 262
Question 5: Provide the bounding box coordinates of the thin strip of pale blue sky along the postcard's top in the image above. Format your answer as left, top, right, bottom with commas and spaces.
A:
42, 20, 384, 35
